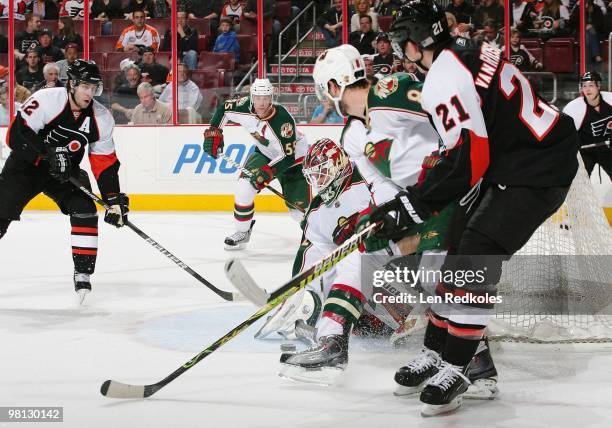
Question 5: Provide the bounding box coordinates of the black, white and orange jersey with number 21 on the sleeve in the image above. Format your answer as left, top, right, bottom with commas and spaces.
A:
420, 37, 578, 208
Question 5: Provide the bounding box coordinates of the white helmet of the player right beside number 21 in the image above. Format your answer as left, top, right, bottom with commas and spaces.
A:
312, 45, 366, 116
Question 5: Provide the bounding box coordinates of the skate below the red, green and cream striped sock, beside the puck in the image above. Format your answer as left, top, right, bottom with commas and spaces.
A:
278, 334, 348, 386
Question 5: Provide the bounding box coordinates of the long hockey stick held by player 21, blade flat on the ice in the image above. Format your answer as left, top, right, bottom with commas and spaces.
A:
100, 224, 379, 398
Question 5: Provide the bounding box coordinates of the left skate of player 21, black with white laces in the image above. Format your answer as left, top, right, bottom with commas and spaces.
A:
393, 347, 442, 396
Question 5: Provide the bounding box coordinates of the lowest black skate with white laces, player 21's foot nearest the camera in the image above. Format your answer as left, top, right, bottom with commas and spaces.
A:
420, 361, 470, 416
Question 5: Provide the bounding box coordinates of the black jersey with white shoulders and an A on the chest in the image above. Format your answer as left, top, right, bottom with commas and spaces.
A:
7, 88, 119, 195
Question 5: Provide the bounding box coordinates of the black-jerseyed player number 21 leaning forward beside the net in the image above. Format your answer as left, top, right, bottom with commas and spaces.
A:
371, 0, 578, 415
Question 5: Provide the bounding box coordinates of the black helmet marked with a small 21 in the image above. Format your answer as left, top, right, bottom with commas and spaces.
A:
389, 0, 451, 58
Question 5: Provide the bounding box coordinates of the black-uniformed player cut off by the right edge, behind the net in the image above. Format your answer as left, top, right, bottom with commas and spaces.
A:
563, 71, 612, 179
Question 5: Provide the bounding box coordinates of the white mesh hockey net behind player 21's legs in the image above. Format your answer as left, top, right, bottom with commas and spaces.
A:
489, 159, 612, 343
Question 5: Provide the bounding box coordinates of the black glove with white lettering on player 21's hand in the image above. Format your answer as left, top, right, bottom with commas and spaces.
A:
370, 189, 431, 242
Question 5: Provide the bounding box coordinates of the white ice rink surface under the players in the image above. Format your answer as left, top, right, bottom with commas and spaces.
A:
0, 212, 612, 428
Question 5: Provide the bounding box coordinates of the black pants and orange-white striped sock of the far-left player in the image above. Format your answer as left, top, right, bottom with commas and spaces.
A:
0, 156, 98, 274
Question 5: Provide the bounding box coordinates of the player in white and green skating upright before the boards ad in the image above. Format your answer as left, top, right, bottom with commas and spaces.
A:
203, 79, 310, 250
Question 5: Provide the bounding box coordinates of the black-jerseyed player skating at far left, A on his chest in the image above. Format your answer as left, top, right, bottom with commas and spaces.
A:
0, 60, 129, 303
